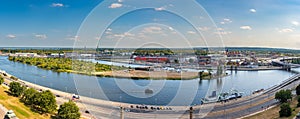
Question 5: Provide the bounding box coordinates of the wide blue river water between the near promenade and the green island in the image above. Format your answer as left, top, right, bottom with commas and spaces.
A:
0, 56, 300, 105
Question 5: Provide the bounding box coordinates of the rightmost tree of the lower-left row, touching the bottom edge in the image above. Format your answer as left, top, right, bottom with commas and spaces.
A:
57, 101, 80, 119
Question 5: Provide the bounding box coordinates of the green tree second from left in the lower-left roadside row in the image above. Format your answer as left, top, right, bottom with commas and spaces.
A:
21, 88, 39, 105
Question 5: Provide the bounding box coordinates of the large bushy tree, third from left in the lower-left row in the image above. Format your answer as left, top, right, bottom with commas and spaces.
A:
34, 90, 57, 113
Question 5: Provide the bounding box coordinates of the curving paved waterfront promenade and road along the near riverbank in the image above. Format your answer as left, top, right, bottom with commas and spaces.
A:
4, 69, 299, 119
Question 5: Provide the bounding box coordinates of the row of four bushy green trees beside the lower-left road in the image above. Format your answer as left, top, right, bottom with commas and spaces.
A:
9, 82, 80, 119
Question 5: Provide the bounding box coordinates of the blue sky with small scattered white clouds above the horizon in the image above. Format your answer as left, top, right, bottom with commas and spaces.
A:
0, 0, 300, 49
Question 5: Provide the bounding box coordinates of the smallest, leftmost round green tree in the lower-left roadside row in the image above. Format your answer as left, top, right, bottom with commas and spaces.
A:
9, 82, 25, 97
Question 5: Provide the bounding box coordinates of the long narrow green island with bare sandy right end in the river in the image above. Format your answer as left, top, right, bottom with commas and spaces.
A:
8, 56, 212, 80
